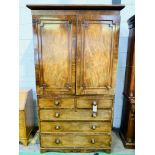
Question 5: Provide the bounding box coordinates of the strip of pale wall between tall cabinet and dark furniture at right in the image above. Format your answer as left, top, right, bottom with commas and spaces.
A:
113, 0, 135, 128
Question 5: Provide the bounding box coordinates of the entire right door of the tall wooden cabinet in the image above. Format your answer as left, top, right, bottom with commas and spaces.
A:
76, 15, 119, 95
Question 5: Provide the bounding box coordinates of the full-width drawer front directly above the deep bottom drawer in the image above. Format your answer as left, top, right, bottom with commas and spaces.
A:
40, 121, 112, 132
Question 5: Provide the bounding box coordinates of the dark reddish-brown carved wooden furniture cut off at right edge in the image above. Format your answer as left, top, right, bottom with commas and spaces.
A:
120, 16, 135, 148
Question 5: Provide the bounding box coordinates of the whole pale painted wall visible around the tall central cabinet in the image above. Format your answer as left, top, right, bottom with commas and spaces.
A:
19, 0, 134, 127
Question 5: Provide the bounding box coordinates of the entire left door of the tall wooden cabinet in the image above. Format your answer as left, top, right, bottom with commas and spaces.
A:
33, 15, 76, 95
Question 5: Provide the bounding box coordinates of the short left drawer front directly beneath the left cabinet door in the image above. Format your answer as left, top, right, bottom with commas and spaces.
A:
39, 98, 74, 108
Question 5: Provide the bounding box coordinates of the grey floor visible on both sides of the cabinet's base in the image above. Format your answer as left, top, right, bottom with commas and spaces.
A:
19, 132, 135, 155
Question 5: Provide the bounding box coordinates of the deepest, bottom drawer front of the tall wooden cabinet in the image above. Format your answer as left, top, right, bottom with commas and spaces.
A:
40, 133, 111, 148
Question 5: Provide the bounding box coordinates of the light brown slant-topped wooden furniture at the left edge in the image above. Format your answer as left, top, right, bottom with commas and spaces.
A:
19, 89, 34, 145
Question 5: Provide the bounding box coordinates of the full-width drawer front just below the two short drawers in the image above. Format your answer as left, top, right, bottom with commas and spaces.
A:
40, 109, 112, 121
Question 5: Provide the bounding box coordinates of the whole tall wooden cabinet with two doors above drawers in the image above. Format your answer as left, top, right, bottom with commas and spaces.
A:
27, 5, 124, 152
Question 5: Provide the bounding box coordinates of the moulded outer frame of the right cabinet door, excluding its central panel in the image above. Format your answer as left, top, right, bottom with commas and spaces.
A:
76, 15, 120, 95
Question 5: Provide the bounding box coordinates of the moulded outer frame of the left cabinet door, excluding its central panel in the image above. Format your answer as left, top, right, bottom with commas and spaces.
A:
33, 15, 76, 95
